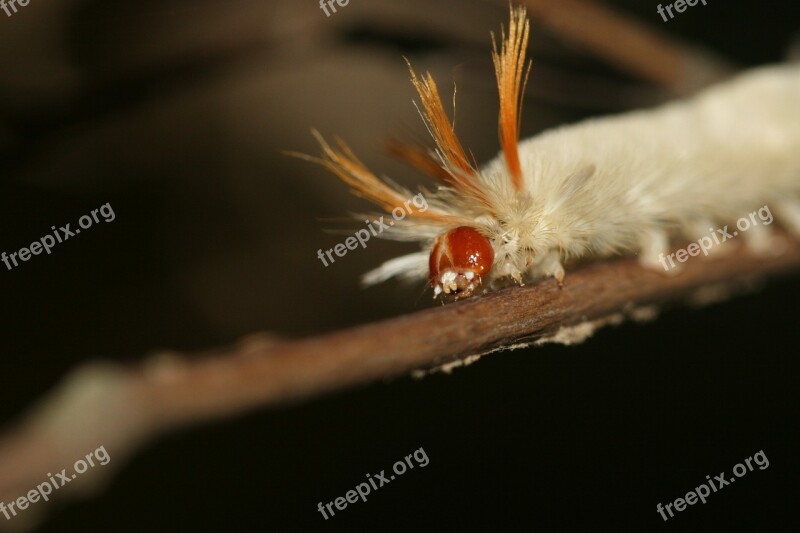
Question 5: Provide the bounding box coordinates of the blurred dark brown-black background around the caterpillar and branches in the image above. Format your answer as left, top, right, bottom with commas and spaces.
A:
0, 0, 800, 532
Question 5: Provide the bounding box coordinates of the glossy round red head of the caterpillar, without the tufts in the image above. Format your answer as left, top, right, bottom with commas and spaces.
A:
428, 226, 494, 298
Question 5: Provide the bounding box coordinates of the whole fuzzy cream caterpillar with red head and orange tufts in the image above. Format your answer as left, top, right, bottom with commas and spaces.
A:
306, 7, 800, 299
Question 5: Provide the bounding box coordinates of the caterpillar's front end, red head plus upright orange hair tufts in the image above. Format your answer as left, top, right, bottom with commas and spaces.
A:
299, 7, 531, 299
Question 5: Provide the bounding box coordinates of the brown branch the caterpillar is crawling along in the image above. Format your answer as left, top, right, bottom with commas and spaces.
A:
0, 238, 800, 527
